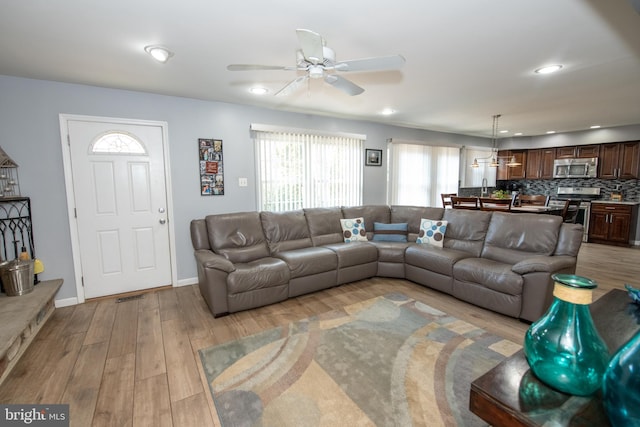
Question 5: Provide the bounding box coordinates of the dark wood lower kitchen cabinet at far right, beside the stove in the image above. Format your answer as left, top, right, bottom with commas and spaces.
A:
589, 203, 635, 246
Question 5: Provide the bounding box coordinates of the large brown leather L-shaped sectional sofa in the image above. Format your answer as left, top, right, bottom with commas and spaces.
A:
191, 205, 582, 321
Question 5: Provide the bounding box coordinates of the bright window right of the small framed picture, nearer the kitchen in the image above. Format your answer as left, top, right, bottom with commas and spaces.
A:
387, 140, 460, 206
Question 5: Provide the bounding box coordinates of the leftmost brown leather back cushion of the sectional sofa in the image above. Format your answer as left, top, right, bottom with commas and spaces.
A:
205, 212, 269, 262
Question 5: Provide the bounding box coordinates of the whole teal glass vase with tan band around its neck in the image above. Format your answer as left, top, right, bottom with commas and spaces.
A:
524, 274, 609, 396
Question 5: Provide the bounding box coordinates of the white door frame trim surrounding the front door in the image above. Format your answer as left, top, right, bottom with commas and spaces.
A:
60, 114, 178, 304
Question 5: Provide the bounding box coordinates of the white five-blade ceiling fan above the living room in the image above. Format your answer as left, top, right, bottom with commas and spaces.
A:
227, 29, 405, 96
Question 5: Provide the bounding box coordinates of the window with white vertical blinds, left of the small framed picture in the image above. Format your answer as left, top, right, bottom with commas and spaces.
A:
251, 125, 365, 211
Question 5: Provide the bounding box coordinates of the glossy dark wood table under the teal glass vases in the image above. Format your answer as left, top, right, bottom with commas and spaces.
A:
469, 289, 640, 427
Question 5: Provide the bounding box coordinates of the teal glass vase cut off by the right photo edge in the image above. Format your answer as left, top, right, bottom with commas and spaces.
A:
602, 332, 640, 427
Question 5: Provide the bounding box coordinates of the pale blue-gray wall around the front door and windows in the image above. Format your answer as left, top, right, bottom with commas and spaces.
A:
0, 76, 489, 299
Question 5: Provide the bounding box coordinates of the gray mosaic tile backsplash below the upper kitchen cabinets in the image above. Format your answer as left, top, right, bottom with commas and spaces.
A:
459, 178, 640, 202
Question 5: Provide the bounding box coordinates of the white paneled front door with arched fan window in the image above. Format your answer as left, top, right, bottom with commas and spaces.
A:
61, 118, 172, 301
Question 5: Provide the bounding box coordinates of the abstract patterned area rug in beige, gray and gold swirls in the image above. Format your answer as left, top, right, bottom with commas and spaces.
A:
200, 294, 520, 427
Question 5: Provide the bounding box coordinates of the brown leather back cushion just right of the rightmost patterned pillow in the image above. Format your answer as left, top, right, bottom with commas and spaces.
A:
442, 209, 492, 257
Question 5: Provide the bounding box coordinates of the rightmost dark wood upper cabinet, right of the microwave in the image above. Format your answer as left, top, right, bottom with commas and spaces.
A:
599, 141, 640, 179
